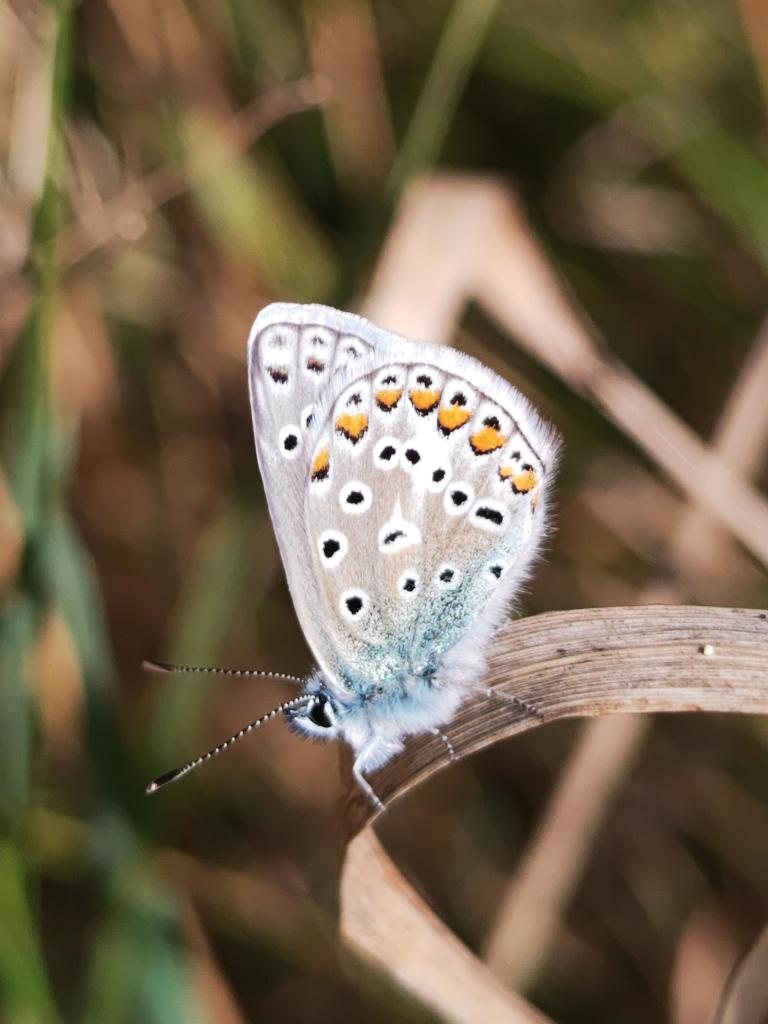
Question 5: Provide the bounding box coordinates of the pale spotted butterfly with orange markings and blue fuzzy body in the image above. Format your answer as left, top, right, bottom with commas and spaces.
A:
148, 303, 559, 809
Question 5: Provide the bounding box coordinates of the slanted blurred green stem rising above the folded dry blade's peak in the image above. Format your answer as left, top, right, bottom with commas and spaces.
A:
389, 0, 498, 191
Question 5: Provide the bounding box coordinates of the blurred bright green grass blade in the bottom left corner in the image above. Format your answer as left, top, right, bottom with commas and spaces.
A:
0, 843, 58, 1024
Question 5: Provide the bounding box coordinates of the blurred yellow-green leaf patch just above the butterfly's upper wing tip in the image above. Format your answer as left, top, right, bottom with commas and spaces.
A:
182, 117, 335, 302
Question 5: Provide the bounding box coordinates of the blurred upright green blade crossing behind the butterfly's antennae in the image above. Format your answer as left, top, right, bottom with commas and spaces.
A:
142, 506, 253, 781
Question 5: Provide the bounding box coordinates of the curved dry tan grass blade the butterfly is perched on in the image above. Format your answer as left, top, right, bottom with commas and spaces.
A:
341, 605, 768, 1024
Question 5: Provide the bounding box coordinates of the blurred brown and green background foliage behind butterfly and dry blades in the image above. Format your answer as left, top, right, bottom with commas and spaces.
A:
0, 0, 768, 1024
